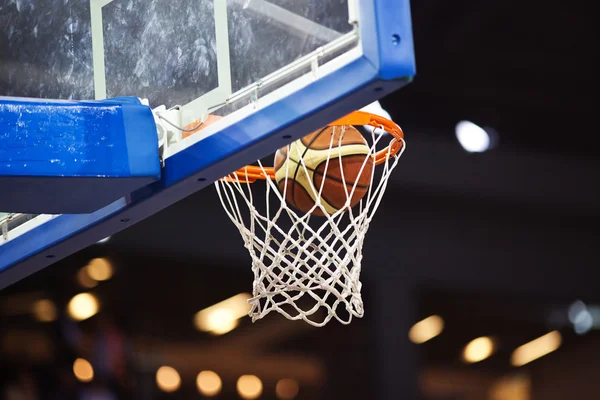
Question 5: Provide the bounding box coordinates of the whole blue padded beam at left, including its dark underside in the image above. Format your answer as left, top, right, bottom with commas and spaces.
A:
0, 97, 160, 214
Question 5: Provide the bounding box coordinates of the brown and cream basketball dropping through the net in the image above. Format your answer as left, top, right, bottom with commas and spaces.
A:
274, 125, 374, 216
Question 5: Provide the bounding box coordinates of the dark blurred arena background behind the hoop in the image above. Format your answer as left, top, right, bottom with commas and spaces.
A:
0, 0, 600, 400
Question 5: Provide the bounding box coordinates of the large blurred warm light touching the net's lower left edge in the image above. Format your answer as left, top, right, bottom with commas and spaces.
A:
194, 293, 252, 335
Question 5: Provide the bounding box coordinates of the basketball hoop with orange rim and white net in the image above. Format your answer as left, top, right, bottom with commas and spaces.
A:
215, 111, 406, 326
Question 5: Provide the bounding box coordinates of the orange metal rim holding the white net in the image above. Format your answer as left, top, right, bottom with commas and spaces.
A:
223, 111, 404, 183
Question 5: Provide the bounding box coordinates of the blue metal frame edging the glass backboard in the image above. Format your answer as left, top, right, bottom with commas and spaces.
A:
0, 0, 416, 289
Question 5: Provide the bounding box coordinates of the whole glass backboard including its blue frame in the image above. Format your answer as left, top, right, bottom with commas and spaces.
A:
0, 0, 415, 288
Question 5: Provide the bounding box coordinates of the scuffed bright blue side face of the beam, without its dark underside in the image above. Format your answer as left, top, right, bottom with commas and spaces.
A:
0, 97, 160, 178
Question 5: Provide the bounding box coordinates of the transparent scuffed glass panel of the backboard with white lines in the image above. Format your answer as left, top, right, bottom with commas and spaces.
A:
0, 0, 358, 124
